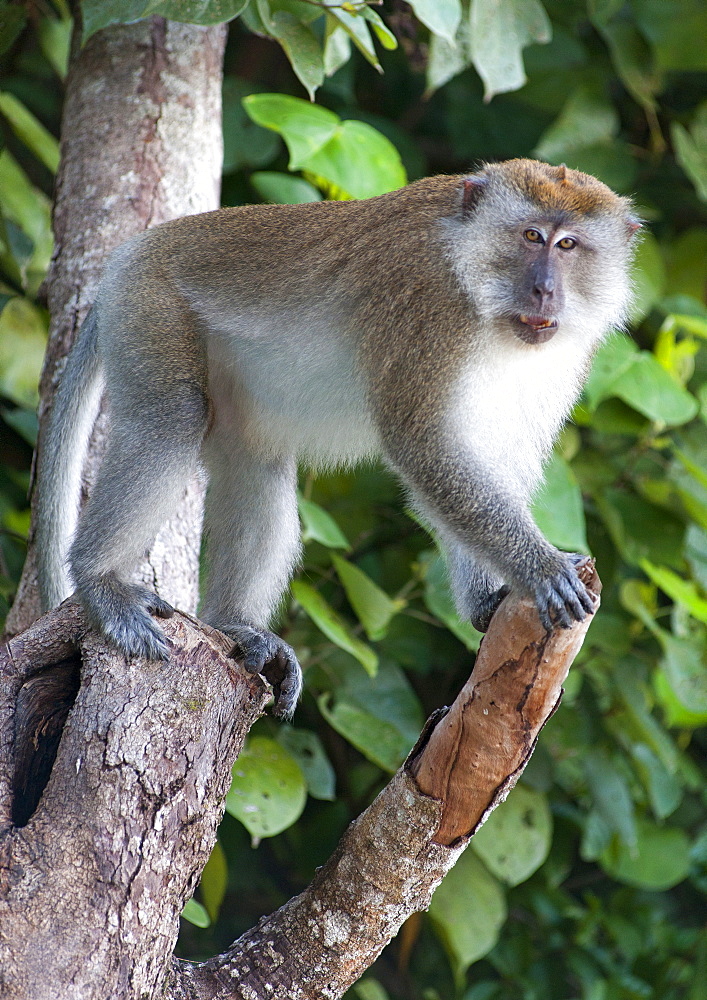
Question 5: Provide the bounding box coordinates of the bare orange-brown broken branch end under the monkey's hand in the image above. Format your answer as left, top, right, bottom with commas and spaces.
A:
409, 558, 601, 845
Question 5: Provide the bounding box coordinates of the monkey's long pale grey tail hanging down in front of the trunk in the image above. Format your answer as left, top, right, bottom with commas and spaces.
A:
35, 309, 103, 611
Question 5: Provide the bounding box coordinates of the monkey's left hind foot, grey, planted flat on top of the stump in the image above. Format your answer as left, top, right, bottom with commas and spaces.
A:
79, 574, 174, 660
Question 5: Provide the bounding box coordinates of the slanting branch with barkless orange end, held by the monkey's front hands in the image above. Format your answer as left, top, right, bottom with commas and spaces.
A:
169, 560, 601, 1000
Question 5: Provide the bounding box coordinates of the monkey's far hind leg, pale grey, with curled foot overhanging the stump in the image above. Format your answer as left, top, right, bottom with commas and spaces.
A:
200, 438, 302, 718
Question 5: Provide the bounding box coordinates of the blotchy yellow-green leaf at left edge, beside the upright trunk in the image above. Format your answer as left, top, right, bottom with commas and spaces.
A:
0, 296, 47, 409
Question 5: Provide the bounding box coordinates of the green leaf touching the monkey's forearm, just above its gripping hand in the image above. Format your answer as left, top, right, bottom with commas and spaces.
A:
533, 455, 589, 552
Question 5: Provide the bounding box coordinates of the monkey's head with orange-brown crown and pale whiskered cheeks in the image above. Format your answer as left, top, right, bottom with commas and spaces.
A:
448, 160, 640, 348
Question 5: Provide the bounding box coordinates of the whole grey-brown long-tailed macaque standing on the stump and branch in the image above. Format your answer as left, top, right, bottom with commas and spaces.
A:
37, 160, 639, 715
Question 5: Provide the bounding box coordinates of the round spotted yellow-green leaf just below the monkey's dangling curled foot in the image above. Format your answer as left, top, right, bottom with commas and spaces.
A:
226, 736, 307, 844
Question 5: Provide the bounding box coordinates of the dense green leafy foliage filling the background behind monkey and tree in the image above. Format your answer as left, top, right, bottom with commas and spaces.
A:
0, 0, 707, 1000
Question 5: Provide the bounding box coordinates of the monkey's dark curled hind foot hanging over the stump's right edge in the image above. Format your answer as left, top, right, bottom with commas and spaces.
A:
228, 625, 302, 719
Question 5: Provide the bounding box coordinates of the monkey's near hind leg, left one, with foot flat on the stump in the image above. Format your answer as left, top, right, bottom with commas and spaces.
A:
69, 381, 207, 660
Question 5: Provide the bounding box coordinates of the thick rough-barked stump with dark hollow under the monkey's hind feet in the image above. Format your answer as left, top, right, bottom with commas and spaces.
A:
0, 602, 269, 1000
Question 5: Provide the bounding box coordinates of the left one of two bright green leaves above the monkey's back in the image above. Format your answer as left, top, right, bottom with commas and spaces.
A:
243, 94, 341, 170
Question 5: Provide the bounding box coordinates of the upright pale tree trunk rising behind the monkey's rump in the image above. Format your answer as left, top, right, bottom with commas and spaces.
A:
6, 18, 226, 635
